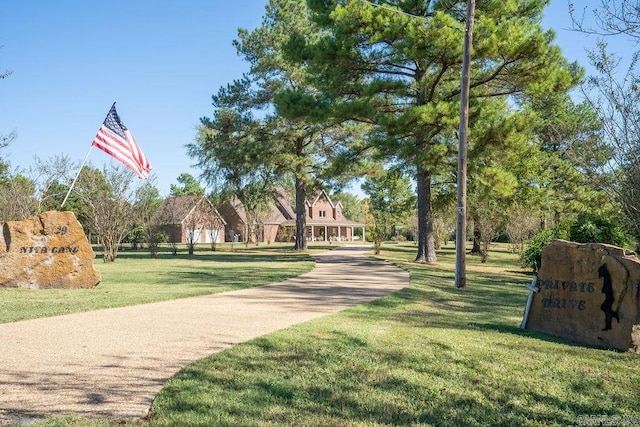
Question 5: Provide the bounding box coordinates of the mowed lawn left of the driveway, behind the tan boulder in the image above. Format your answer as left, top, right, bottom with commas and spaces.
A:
0, 245, 321, 323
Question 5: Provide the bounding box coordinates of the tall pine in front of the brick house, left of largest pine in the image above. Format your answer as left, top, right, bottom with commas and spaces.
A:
190, 0, 364, 250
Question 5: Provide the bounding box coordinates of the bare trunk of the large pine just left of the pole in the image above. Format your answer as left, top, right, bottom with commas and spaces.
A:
416, 166, 438, 264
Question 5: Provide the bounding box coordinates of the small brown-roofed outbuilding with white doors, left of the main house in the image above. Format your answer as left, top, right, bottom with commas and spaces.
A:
152, 195, 226, 243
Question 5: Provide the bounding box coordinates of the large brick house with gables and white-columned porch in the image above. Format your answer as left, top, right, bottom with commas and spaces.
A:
220, 189, 365, 242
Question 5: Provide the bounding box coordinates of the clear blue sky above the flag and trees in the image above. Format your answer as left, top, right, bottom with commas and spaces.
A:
0, 0, 632, 195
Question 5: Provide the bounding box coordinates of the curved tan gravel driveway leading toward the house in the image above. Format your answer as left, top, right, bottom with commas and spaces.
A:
0, 246, 409, 424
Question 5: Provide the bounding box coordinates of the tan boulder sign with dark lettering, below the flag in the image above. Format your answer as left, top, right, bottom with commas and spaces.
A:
0, 211, 101, 289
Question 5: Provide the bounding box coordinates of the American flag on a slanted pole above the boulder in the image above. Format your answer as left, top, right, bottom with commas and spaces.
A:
91, 102, 151, 179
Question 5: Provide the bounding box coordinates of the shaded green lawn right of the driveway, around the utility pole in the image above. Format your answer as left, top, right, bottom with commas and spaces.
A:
15, 245, 640, 426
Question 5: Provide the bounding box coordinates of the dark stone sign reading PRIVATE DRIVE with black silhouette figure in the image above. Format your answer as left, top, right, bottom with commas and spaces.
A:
523, 240, 640, 352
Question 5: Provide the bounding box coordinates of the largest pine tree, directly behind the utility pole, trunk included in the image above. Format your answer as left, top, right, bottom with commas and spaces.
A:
288, 0, 574, 262
